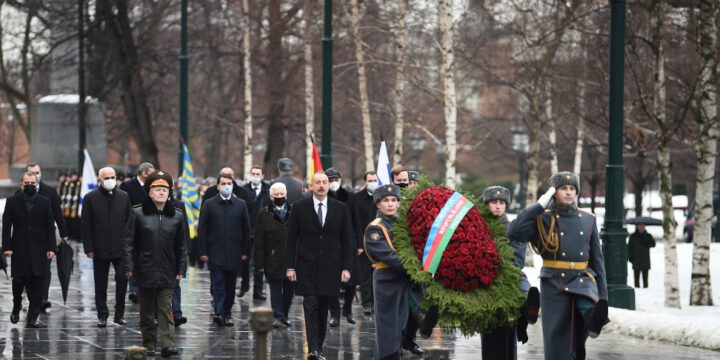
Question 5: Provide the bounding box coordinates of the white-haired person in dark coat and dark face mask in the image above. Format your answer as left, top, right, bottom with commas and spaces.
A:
255, 183, 294, 328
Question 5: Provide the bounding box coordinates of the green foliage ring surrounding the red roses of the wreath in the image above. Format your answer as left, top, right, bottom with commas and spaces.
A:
393, 177, 525, 336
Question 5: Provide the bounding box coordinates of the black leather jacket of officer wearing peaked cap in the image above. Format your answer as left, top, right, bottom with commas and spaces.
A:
123, 198, 187, 289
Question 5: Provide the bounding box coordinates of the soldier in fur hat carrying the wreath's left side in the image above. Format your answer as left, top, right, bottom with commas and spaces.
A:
364, 185, 411, 360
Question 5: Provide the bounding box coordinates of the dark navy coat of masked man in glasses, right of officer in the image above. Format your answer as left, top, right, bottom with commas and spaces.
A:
198, 195, 251, 270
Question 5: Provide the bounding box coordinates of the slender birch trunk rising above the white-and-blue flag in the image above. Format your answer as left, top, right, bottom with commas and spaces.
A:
393, 0, 408, 164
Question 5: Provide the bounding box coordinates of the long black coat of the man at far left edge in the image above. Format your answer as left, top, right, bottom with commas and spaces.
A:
2, 192, 57, 277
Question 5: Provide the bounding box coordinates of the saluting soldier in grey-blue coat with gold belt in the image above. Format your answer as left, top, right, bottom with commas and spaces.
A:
508, 172, 609, 360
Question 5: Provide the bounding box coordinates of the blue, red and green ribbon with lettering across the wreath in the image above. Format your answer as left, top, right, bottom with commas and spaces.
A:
422, 192, 473, 275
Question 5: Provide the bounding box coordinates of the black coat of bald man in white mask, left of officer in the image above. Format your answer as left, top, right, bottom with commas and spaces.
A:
81, 188, 131, 259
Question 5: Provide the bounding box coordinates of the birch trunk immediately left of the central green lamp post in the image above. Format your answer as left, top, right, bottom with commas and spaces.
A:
303, 1, 315, 178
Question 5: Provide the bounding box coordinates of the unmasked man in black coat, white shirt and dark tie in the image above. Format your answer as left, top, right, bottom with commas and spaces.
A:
285, 172, 355, 359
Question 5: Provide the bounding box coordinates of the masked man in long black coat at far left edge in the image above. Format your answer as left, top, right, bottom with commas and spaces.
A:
2, 172, 56, 328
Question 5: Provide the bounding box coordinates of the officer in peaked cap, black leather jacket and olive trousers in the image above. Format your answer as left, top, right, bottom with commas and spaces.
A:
123, 171, 187, 357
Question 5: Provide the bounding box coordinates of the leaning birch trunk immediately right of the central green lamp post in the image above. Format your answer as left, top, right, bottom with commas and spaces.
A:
350, 0, 375, 171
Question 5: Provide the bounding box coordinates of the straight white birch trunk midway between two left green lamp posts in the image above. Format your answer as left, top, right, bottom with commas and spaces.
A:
243, 0, 253, 179
